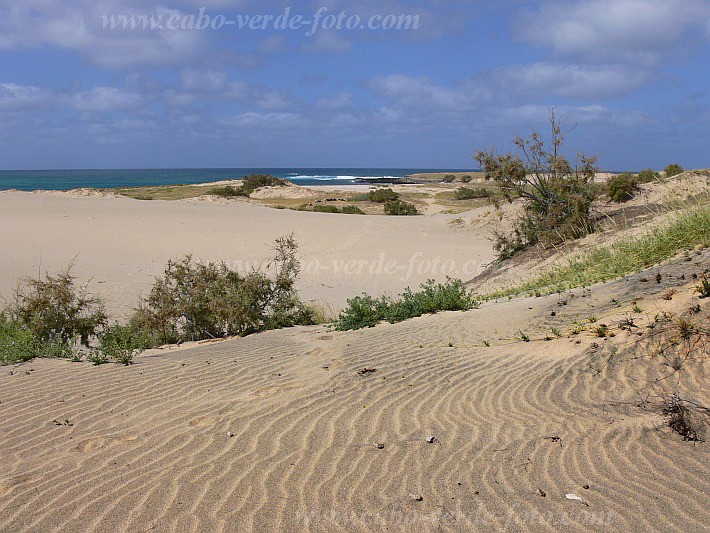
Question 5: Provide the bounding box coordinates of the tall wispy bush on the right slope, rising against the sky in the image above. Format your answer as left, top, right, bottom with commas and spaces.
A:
474, 110, 597, 259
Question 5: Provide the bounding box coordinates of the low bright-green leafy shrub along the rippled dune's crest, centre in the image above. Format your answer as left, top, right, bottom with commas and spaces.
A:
335, 278, 478, 331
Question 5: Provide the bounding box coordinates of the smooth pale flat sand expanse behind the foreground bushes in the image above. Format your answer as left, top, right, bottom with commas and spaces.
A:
0, 191, 495, 316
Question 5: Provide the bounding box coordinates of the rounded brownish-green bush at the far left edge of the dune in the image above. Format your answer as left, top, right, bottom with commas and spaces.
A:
5, 265, 107, 347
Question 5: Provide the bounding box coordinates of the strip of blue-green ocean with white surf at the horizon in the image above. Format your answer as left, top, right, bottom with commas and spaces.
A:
0, 168, 466, 191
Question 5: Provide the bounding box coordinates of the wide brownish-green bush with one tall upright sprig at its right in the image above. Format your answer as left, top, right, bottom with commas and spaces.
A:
138, 235, 313, 343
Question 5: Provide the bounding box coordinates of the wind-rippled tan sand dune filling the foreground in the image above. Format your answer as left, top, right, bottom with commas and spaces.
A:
0, 251, 710, 531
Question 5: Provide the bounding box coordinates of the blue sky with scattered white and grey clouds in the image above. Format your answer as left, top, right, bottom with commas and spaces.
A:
0, 0, 710, 170
